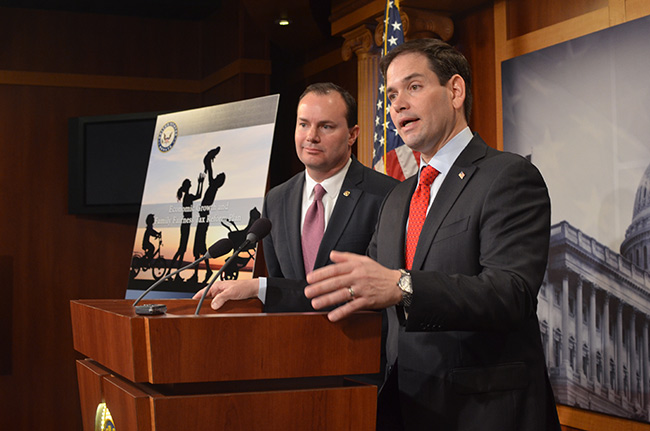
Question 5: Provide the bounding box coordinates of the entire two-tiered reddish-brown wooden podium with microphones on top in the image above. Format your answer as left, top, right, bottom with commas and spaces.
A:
70, 299, 381, 431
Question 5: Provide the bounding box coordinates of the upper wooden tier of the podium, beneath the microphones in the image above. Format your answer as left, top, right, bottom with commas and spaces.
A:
71, 300, 381, 383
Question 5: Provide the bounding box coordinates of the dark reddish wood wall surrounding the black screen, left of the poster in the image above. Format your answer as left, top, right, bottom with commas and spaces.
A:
0, 85, 198, 430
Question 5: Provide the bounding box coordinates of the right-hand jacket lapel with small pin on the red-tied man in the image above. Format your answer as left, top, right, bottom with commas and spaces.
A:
413, 135, 487, 269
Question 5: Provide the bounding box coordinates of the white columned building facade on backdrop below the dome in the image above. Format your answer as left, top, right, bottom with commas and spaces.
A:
538, 222, 650, 421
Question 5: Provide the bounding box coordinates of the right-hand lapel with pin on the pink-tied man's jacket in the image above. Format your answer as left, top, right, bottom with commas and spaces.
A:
314, 158, 363, 268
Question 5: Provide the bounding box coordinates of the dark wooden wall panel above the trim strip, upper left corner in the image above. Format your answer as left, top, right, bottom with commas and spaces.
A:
0, 8, 201, 79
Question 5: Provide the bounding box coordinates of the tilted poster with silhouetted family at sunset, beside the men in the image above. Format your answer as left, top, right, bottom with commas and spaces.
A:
126, 95, 279, 299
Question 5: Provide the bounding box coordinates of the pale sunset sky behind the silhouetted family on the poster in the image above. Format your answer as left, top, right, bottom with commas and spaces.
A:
134, 124, 273, 264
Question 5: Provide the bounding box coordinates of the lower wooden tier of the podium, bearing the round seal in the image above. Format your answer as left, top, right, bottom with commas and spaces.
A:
77, 360, 377, 431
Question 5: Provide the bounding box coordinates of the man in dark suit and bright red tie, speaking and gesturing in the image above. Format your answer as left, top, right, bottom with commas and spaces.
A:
305, 39, 560, 431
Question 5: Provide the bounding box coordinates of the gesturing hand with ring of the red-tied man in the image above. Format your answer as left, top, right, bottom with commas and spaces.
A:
305, 251, 402, 322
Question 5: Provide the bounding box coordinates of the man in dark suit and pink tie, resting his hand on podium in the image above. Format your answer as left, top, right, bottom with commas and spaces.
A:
195, 83, 398, 312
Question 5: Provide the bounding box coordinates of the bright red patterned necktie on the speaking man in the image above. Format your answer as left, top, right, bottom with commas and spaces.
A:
406, 165, 440, 269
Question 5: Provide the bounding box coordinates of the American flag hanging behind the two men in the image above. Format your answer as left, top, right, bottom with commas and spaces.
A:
372, 0, 420, 181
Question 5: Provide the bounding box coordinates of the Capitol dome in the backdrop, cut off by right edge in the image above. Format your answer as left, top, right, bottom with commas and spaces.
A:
621, 165, 650, 270
